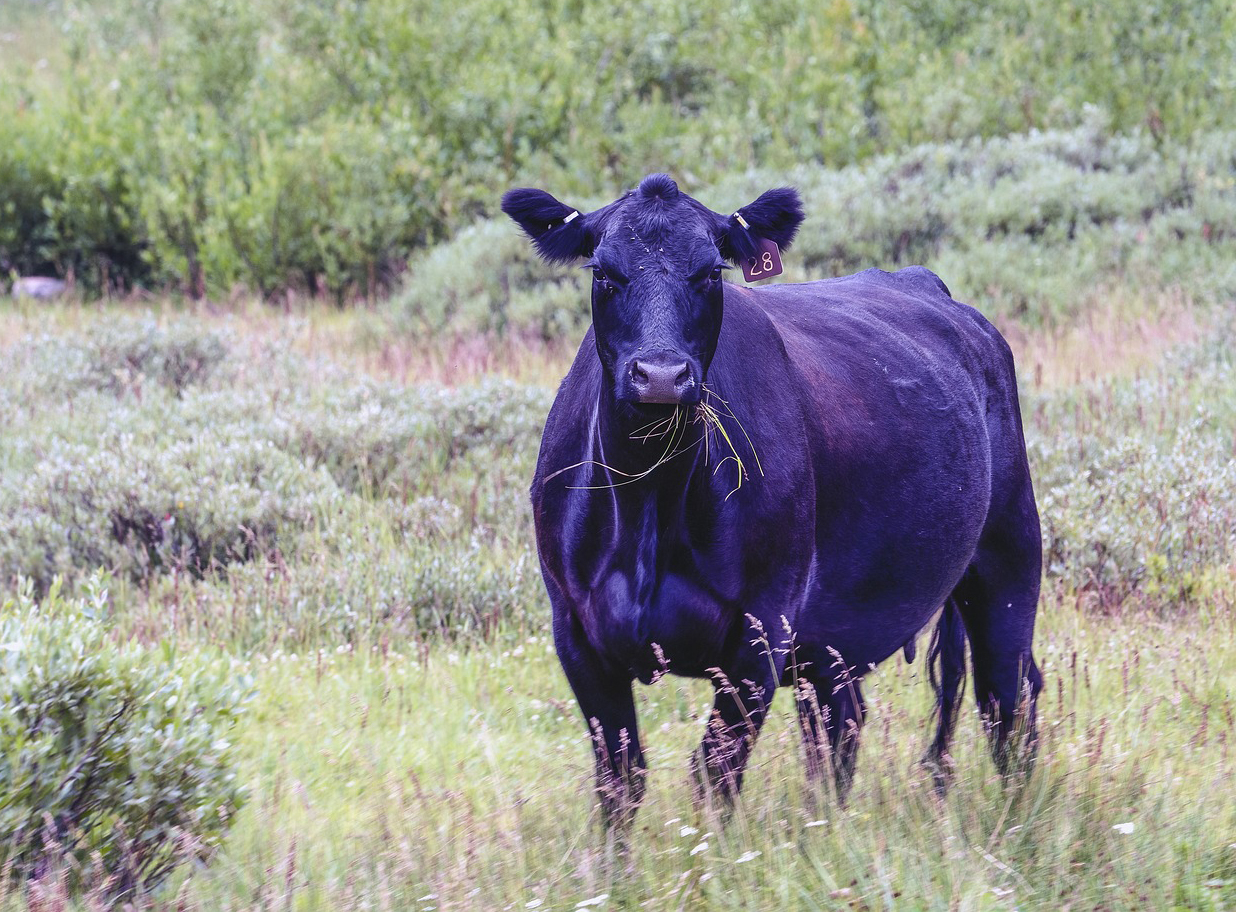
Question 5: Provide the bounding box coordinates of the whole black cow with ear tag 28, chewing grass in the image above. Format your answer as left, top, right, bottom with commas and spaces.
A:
502, 174, 1042, 822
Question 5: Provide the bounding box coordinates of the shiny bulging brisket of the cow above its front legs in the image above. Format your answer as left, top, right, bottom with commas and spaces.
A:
585, 570, 734, 681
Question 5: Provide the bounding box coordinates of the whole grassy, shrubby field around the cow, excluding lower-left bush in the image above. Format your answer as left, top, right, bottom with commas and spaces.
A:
0, 290, 1236, 912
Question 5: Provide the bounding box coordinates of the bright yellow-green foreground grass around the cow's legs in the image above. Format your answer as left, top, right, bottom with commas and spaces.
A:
171, 589, 1236, 910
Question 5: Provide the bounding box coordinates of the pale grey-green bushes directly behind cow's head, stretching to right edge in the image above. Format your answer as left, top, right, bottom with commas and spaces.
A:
393, 122, 1236, 335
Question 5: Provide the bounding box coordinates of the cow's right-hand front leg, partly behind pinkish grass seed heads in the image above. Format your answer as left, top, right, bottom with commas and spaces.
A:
693, 618, 786, 802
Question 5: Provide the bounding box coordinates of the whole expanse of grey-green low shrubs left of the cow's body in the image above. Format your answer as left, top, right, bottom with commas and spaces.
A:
0, 318, 551, 645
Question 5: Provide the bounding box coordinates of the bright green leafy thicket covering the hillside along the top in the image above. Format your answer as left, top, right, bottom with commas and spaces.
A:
0, 0, 1236, 299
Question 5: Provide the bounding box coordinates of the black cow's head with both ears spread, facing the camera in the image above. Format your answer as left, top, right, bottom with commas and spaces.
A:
502, 174, 802, 405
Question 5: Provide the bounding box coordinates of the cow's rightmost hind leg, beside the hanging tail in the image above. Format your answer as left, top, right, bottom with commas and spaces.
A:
953, 511, 1043, 775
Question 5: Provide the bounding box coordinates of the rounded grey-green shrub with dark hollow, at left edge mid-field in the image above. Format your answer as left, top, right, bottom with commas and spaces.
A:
0, 397, 337, 587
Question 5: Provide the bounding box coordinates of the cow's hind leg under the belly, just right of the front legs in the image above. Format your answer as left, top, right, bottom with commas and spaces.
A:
795, 675, 866, 803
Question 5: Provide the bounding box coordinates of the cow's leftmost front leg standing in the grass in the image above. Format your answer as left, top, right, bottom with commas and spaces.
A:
554, 608, 645, 828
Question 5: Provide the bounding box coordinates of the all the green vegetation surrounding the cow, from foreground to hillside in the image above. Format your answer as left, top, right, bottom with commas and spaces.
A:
0, 0, 1236, 912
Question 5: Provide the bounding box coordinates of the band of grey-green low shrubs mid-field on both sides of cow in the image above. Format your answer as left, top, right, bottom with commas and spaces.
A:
0, 312, 1236, 648
